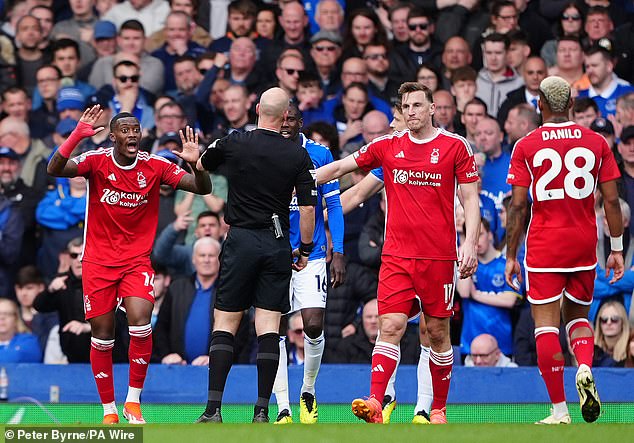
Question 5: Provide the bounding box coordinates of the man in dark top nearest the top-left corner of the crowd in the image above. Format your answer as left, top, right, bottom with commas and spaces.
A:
15, 15, 50, 95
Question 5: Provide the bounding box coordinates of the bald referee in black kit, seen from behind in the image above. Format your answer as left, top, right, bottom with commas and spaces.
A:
197, 88, 317, 423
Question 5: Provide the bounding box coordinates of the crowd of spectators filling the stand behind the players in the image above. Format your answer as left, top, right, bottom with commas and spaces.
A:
0, 0, 634, 367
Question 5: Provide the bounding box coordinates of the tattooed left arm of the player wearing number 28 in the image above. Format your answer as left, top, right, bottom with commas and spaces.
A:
504, 185, 528, 291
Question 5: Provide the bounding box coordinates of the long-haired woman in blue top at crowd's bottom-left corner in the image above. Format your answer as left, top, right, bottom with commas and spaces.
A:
0, 294, 42, 363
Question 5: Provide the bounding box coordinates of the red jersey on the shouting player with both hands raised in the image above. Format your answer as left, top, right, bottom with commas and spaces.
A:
72, 148, 186, 266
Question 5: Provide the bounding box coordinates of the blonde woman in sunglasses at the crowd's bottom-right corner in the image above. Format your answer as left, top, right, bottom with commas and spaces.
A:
593, 301, 630, 366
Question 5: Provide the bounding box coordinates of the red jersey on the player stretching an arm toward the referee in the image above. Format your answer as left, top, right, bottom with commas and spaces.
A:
354, 129, 478, 260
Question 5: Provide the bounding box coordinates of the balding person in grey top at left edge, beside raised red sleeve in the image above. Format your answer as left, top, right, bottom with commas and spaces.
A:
0, 117, 51, 197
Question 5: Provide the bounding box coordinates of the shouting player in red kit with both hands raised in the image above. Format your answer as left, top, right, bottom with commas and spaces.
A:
48, 105, 211, 424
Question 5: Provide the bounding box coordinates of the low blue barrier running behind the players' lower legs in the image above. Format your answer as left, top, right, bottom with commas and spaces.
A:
4, 364, 634, 404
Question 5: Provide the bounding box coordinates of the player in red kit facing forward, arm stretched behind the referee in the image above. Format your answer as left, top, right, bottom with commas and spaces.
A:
317, 82, 480, 424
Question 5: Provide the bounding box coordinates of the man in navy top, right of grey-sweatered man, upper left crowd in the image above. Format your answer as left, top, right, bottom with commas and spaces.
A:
152, 11, 206, 93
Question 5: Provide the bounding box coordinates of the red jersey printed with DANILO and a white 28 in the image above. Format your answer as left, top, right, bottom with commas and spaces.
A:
507, 122, 621, 272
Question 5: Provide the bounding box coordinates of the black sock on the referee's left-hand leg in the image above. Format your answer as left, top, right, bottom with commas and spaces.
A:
205, 331, 233, 415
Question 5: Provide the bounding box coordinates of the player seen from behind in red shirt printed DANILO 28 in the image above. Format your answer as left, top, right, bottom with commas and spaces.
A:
505, 76, 624, 424
